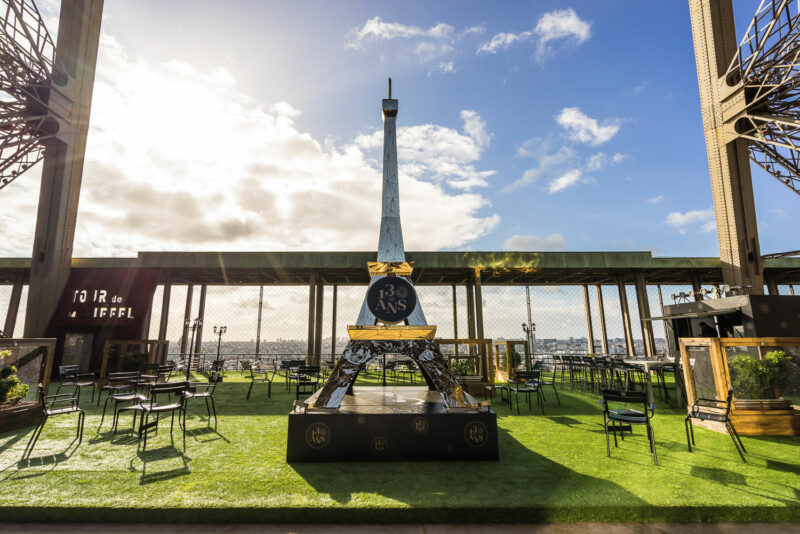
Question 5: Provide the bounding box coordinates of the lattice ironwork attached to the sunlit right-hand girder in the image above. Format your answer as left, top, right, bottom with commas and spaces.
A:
725, 0, 800, 194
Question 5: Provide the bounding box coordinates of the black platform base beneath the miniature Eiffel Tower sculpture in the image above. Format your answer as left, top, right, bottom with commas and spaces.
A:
286, 387, 499, 462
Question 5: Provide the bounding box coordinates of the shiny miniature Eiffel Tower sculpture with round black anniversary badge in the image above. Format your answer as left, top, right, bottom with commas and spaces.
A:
312, 78, 478, 409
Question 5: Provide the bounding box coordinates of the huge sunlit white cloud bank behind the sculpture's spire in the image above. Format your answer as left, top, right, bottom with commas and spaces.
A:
0, 35, 499, 256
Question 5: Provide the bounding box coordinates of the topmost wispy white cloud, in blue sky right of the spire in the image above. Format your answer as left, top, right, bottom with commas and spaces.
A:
477, 9, 592, 61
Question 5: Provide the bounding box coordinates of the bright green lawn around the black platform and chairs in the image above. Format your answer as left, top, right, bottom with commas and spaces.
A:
0, 374, 800, 522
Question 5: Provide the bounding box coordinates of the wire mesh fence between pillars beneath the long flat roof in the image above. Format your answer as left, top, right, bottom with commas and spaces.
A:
0, 278, 795, 366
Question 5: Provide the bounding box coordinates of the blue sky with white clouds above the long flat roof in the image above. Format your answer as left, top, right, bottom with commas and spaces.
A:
0, 0, 800, 256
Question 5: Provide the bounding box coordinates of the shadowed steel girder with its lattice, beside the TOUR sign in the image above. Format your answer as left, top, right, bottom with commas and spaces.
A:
0, 0, 103, 337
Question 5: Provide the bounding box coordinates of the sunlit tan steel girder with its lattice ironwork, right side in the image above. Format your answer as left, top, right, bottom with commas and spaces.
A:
689, 0, 800, 294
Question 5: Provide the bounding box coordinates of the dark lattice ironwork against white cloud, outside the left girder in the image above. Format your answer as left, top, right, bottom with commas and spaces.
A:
0, 0, 66, 189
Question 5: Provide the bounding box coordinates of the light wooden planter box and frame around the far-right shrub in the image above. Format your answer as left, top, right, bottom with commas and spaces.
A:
679, 337, 800, 436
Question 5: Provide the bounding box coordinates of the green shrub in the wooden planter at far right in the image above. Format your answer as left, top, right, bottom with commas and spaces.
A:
728, 350, 794, 399
